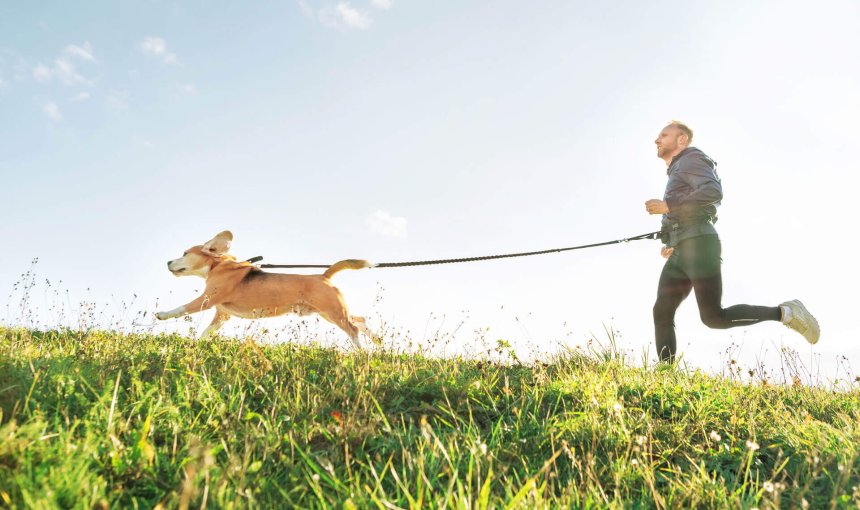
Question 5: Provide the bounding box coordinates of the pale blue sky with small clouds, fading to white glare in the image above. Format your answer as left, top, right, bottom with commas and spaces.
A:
0, 0, 860, 382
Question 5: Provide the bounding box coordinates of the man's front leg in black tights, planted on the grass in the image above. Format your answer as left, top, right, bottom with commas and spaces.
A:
654, 257, 693, 362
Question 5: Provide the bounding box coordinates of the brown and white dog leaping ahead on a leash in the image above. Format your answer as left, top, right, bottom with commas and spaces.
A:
155, 230, 373, 349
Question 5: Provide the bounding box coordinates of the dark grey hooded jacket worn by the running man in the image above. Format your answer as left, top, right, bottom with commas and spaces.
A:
662, 147, 723, 246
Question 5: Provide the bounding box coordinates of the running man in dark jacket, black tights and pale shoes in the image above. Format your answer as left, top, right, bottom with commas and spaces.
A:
645, 121, 820, 362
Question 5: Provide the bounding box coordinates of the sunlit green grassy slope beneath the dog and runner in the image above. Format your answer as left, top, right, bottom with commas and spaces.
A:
0, 328, 860, 509
